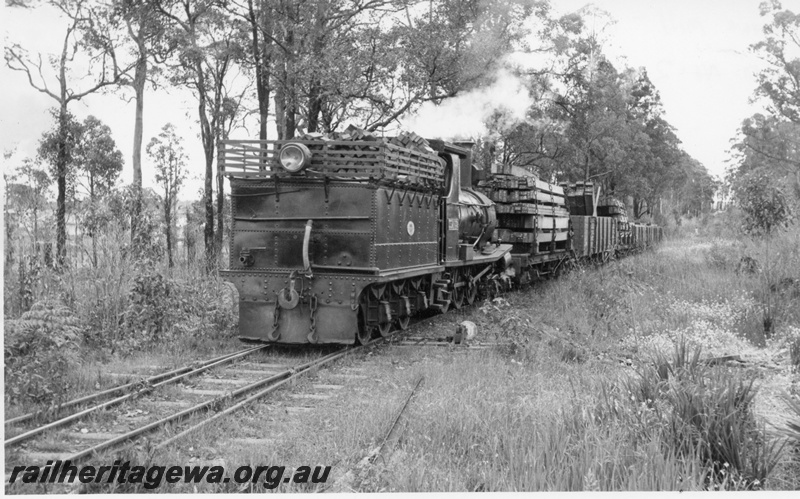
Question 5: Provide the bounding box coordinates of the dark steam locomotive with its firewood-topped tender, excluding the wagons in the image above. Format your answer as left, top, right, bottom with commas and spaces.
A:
220, 127, 511, 343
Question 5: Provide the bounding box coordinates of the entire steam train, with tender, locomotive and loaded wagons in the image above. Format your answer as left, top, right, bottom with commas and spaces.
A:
219, 131, 662, 344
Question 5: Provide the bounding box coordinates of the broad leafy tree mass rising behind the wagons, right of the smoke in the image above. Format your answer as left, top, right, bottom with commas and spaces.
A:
494, 9, 713, 221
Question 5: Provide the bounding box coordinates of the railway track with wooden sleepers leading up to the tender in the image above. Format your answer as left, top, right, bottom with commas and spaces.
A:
5, 338, 404, 492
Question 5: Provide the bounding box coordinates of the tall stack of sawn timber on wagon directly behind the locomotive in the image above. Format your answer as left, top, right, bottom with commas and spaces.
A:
479, 174, 570, 268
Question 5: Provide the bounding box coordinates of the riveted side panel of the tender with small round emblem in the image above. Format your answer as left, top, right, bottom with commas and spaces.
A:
373, 188, 439, 271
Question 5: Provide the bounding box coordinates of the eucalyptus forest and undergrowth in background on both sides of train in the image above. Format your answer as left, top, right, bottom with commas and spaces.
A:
4, 0, 800, 378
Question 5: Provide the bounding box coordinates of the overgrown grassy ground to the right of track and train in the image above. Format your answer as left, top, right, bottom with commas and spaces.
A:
7, 221, 800, 492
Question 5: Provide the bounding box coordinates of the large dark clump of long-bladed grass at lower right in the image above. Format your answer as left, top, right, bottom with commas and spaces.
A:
626, 341, 782, 489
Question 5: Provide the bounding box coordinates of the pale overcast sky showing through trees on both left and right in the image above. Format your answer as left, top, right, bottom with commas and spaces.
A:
0, 0, 765, 197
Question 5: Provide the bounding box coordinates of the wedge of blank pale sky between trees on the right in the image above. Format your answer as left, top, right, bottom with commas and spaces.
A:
553, 0, 768, 179
